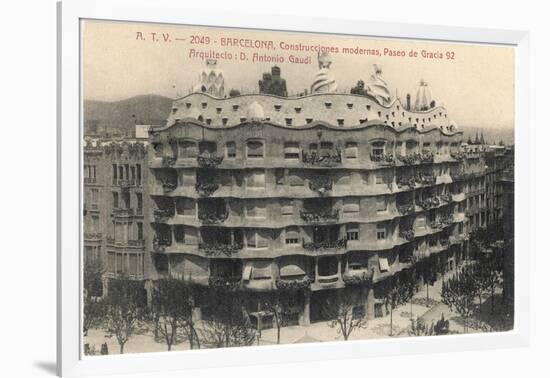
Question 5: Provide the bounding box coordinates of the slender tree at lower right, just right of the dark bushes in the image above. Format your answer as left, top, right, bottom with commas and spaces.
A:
441, 267, 476, 333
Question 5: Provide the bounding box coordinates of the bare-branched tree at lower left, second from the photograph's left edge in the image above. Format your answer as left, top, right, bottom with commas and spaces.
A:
104, 277, 145, 354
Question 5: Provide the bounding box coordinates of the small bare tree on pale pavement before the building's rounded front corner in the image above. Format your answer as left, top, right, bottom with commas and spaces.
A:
324, 291, 367, 341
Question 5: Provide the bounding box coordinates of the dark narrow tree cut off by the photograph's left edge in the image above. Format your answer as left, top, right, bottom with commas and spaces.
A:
82, 258, 105, 336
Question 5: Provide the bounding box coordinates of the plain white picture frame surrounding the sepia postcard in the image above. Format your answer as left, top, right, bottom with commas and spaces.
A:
57, 0, 529, 376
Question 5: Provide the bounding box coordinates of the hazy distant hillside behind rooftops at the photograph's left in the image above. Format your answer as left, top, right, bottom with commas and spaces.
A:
84, 95, 172, 136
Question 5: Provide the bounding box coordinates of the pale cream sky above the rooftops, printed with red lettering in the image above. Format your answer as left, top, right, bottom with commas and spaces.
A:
82, 20, 515, 128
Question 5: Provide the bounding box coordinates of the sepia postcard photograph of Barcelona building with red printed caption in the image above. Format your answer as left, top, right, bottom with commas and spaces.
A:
80, 19, 516, 358
